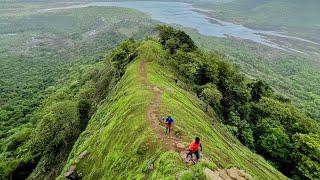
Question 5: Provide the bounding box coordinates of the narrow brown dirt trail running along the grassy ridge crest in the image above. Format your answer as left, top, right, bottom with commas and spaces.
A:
139, 61, 185, 154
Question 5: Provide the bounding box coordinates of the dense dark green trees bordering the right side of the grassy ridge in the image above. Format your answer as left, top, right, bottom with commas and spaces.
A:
156, 27, 320, 179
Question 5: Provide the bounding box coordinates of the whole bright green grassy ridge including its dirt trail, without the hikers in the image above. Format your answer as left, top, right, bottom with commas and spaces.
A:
59, 41, 286, 179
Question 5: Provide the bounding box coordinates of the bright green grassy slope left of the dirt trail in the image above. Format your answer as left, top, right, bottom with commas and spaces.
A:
58, 58, 186, 179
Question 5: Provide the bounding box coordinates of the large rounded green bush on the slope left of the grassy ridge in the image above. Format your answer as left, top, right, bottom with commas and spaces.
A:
30, 101, 81, 154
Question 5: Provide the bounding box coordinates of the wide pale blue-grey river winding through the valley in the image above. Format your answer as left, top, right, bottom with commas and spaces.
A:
44, 1, 320, 53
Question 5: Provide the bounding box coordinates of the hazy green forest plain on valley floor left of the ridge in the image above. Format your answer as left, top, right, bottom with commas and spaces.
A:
0, 4, 153, 178
